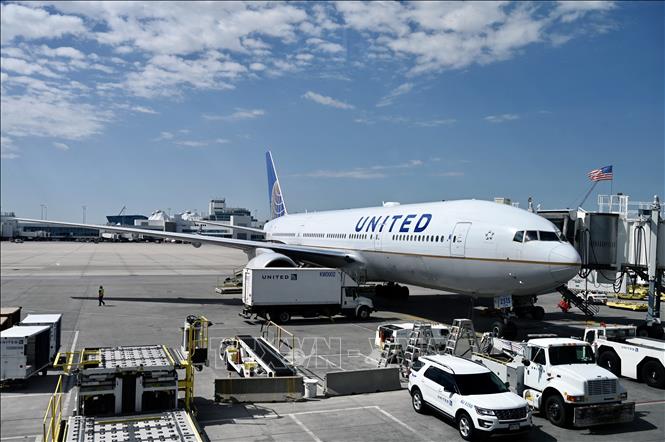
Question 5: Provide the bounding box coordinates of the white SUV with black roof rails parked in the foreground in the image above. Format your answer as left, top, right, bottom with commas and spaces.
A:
409, 354, 531, 440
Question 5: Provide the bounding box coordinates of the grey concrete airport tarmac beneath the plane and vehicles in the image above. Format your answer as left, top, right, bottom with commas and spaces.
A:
0, 242, 665, 441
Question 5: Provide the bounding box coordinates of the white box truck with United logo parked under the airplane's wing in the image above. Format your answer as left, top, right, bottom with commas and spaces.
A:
242, 267, 374, 324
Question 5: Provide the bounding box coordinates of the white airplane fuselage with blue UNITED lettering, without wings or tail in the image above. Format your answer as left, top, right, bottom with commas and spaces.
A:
265, 200, 580, 297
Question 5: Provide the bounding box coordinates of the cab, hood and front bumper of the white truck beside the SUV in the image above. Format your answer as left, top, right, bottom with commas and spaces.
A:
522, 338, 635, 426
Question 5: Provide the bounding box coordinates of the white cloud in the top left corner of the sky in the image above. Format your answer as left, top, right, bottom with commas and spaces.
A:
0, 4, 86, 45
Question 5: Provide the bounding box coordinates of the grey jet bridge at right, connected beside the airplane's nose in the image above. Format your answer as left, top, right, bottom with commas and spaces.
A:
538, 194, 665, 337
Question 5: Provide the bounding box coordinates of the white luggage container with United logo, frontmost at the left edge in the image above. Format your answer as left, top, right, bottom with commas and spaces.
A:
0, 325, 51, 382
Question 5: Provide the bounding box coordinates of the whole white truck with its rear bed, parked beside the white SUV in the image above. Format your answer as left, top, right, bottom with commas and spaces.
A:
473, 336, 635, 427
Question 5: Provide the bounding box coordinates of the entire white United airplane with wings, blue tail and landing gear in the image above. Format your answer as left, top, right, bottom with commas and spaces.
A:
18, 151, 581, 336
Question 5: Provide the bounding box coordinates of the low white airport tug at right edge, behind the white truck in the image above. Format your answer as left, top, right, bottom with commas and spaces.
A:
584, 325, 665, 388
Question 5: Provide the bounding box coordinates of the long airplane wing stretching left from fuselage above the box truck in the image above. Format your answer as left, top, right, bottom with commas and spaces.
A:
14, 218, 361, 267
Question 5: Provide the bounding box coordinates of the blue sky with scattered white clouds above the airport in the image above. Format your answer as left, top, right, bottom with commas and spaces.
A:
1, 2, 665, 222
